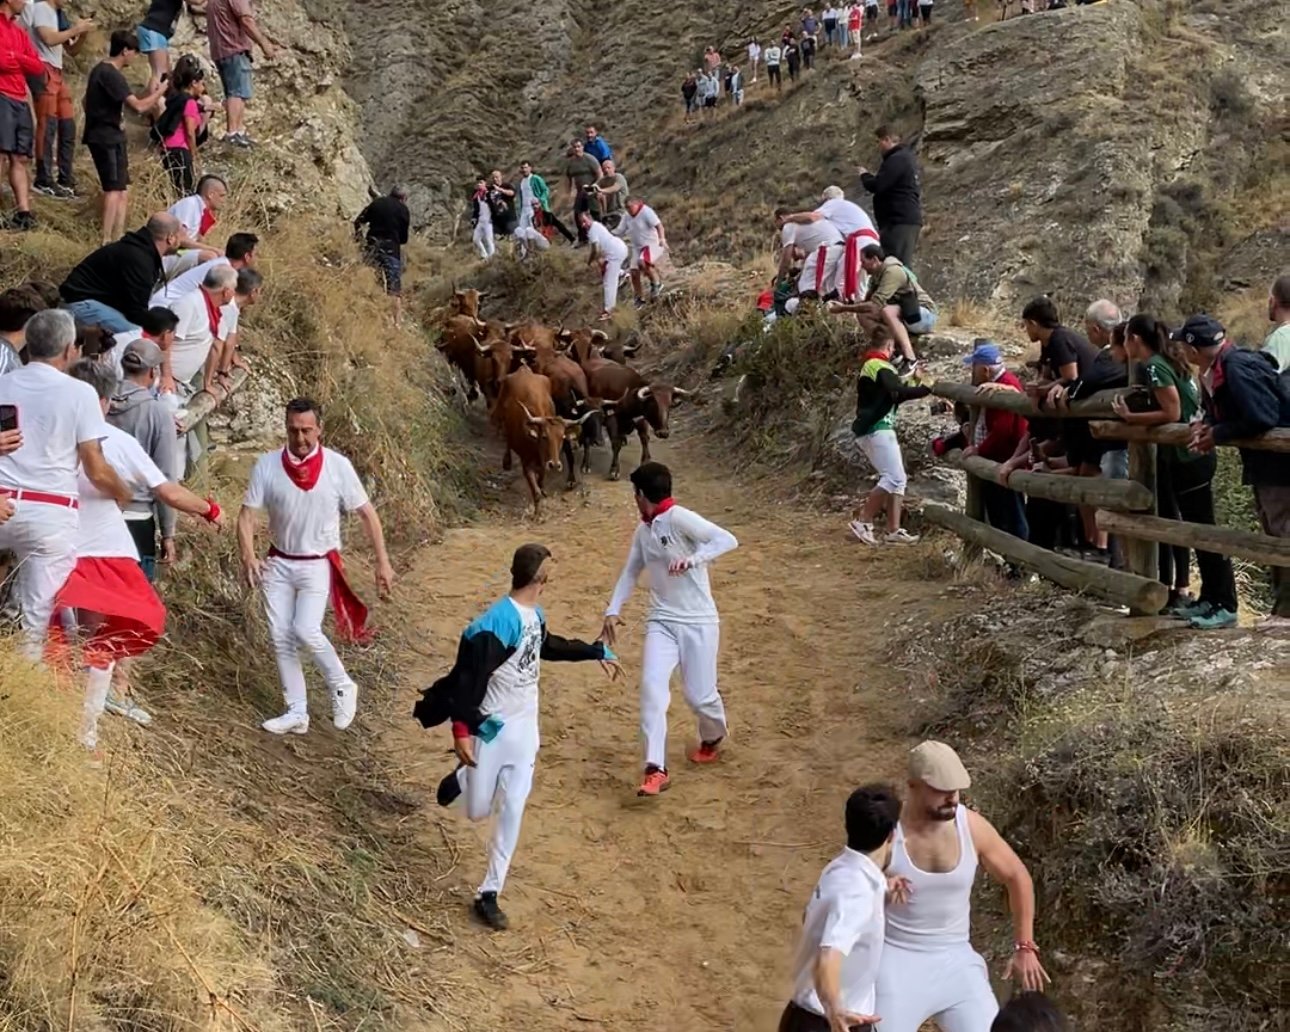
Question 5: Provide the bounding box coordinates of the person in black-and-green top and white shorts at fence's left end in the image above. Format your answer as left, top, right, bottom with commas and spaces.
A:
849, 326, 931, 544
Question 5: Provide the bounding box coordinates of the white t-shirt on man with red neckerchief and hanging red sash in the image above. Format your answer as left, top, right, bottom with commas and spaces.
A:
243, 448, 368, 556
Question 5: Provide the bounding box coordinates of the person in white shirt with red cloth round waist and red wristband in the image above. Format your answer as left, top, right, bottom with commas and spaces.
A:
55, 359, 219, 749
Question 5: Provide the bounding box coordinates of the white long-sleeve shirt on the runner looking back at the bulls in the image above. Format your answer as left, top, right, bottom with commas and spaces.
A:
605, 506, 739, 624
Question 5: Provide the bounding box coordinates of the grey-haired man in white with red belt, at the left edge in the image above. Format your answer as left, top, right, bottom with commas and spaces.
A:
0, 308, 130, 662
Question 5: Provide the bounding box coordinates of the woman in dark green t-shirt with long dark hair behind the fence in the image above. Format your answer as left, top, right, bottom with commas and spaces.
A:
1115, 315, 1237, 626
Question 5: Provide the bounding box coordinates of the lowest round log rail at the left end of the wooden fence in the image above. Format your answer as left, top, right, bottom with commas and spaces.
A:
922, 502, 1169, 613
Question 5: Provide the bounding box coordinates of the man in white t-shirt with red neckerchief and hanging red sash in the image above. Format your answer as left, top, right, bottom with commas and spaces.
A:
237, 397, 395, 734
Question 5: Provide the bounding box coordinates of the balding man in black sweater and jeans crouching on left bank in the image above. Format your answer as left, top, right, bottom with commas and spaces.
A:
58, 212, 183, 333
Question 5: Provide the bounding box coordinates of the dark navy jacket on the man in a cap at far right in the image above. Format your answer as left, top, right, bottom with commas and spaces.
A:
1201, 344, 1290, 488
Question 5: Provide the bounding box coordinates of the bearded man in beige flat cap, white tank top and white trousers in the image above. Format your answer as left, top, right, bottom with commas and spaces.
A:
877, 742, 1049, 1032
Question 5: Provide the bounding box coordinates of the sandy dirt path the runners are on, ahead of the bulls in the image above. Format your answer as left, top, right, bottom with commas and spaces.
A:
376, 445, 964, 1032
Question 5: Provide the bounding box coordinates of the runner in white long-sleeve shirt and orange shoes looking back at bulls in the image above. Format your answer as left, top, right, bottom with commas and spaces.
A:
601, 462, 739, 796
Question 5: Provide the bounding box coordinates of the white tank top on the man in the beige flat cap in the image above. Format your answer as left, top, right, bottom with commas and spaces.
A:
885, 805, 977, 951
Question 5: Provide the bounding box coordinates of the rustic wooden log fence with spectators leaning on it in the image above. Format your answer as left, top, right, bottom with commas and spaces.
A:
922, 383, 1290, 615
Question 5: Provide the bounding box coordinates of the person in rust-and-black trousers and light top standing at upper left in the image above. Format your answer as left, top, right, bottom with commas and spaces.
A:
23, 0, 94, 199
